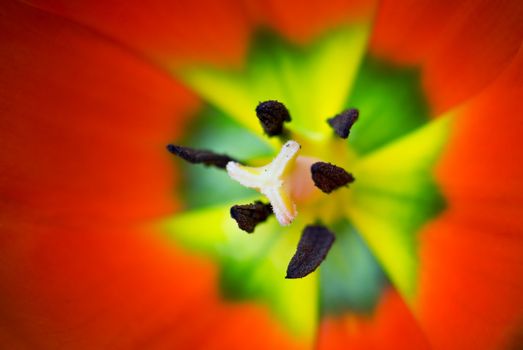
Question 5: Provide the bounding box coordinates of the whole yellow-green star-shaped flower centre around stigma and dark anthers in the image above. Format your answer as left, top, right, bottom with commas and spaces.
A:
165, 23, 450, 337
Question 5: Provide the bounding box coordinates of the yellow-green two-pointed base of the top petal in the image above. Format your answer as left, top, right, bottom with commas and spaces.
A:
175, 22, 369, 144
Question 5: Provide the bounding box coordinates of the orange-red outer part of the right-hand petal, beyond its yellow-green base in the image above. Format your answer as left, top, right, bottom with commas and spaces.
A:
417, 52, 523, 349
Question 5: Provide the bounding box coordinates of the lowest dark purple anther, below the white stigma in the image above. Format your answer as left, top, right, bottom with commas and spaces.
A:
285, 225, 335, 278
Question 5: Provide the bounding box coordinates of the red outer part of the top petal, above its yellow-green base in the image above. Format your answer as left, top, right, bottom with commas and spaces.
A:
29, 0, 376, 67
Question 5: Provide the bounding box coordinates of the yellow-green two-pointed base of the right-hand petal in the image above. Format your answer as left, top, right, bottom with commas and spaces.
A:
346, 115, 451, 301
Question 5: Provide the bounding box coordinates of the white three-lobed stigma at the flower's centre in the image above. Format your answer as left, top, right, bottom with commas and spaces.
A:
227, 141, 301, 226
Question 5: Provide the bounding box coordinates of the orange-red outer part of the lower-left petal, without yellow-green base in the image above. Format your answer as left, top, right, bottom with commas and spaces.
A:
0, 224, 303, 349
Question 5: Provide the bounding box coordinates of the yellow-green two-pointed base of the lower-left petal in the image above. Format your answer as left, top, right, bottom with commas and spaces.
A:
162, 201, 318, 341
